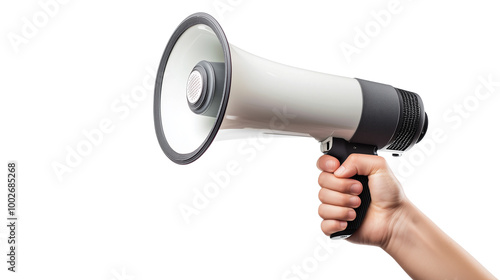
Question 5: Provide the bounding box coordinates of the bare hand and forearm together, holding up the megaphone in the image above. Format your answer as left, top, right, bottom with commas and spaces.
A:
317, 154, 496, 279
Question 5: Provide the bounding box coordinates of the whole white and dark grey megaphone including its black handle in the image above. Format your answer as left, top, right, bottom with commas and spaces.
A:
154, 13, 428, 238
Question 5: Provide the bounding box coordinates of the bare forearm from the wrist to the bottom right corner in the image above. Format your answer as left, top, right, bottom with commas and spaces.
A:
382, 201, 495, 280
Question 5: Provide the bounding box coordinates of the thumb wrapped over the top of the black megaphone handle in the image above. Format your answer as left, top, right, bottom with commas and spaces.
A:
334, 154, 387, 178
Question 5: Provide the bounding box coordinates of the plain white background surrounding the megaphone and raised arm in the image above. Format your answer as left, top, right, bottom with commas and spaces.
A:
0, 0, 500, 280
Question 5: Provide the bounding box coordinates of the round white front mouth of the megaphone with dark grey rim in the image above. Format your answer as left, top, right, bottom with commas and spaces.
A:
154, 13, 231, 164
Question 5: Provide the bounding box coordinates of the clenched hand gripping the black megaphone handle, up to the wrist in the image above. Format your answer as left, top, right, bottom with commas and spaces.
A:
317, 154, 406, 247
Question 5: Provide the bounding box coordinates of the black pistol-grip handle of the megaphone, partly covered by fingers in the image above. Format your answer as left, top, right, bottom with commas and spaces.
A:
323, 138, 377, 239
